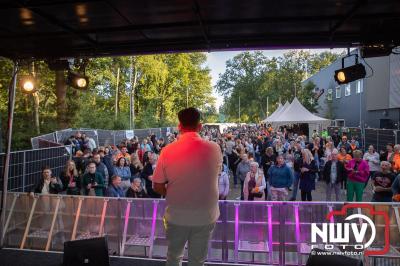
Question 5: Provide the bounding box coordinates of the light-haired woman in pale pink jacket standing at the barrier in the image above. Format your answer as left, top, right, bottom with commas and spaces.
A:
243, 162, 267, 201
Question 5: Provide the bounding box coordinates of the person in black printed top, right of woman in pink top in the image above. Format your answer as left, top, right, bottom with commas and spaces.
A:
372, 161, 396, 202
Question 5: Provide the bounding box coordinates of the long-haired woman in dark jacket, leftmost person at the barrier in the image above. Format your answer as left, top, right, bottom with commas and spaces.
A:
31, 166, 63, 195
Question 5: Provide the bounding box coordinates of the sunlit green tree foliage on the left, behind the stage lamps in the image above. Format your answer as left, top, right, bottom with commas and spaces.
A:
0, 53, 216, 150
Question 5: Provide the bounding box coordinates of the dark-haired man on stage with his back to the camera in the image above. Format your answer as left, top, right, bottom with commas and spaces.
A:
153, 108, 222, 266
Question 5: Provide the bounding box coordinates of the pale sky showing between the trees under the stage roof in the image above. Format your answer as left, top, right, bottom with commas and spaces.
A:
206, 49, 345, 110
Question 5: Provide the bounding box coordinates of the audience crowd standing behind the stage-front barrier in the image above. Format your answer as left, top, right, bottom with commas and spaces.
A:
32, 125, 400, 202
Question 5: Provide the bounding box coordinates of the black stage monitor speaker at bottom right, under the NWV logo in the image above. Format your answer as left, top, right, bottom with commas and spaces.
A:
306, 248, 363, 266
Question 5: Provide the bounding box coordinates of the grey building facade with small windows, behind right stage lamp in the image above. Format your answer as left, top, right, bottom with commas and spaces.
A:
303, 50, 400, 129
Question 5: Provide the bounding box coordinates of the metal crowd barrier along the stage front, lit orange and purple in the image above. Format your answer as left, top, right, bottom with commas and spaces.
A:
4, 193, 400, 265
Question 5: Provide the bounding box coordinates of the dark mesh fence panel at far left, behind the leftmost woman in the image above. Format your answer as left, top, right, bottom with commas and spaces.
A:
0, 146, 71, 192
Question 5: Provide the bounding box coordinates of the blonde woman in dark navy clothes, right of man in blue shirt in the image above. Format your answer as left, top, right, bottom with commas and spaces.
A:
299, 149, 318, 201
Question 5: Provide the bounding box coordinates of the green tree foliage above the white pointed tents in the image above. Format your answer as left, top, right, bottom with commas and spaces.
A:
216, 50, 339, 122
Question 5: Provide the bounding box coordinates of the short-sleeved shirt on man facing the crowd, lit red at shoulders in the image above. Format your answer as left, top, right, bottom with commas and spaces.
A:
153, 132, 222, 226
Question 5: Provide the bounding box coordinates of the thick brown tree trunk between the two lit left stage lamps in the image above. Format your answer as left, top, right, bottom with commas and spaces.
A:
56, 70, 69, 129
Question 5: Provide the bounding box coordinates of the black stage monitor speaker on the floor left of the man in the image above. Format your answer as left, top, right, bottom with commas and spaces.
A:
63, 237, 110, 266
